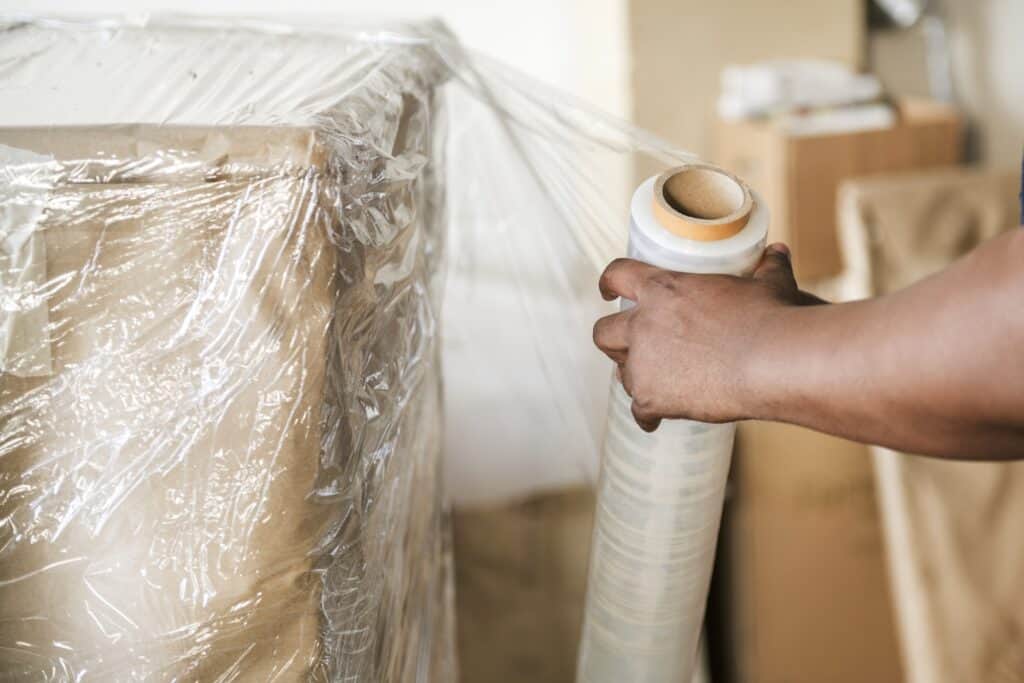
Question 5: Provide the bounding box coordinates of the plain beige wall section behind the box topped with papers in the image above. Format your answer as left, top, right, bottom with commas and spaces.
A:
629, 0, 864, 175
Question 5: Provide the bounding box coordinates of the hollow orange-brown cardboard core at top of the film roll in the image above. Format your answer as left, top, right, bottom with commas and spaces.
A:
654, 164, 754, 242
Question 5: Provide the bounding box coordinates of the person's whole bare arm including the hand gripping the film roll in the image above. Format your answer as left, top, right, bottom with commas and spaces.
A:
594, 230, 1024, 460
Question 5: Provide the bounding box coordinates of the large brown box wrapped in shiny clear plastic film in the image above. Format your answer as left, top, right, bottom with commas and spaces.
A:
0, 23, 454, 681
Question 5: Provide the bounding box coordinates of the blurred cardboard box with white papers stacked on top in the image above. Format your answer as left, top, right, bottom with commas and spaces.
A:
715, 100, 963, 280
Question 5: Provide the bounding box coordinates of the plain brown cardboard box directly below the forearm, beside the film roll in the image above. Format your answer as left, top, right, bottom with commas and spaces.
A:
711, 422, 902, 683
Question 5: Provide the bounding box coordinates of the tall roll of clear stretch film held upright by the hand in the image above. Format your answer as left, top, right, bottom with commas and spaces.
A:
577, 164, 768, 683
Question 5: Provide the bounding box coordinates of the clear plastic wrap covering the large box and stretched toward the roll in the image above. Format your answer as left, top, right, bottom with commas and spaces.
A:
0, 12, 729, 681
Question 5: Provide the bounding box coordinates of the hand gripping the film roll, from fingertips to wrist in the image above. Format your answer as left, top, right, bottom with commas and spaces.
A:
594, 244, 824, 431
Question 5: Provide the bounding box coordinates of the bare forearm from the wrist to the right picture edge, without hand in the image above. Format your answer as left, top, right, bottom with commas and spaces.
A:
748, 229, 1024, 459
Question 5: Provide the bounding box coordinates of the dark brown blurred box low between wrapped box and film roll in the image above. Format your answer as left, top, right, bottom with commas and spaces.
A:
453, 488, 595, 683
